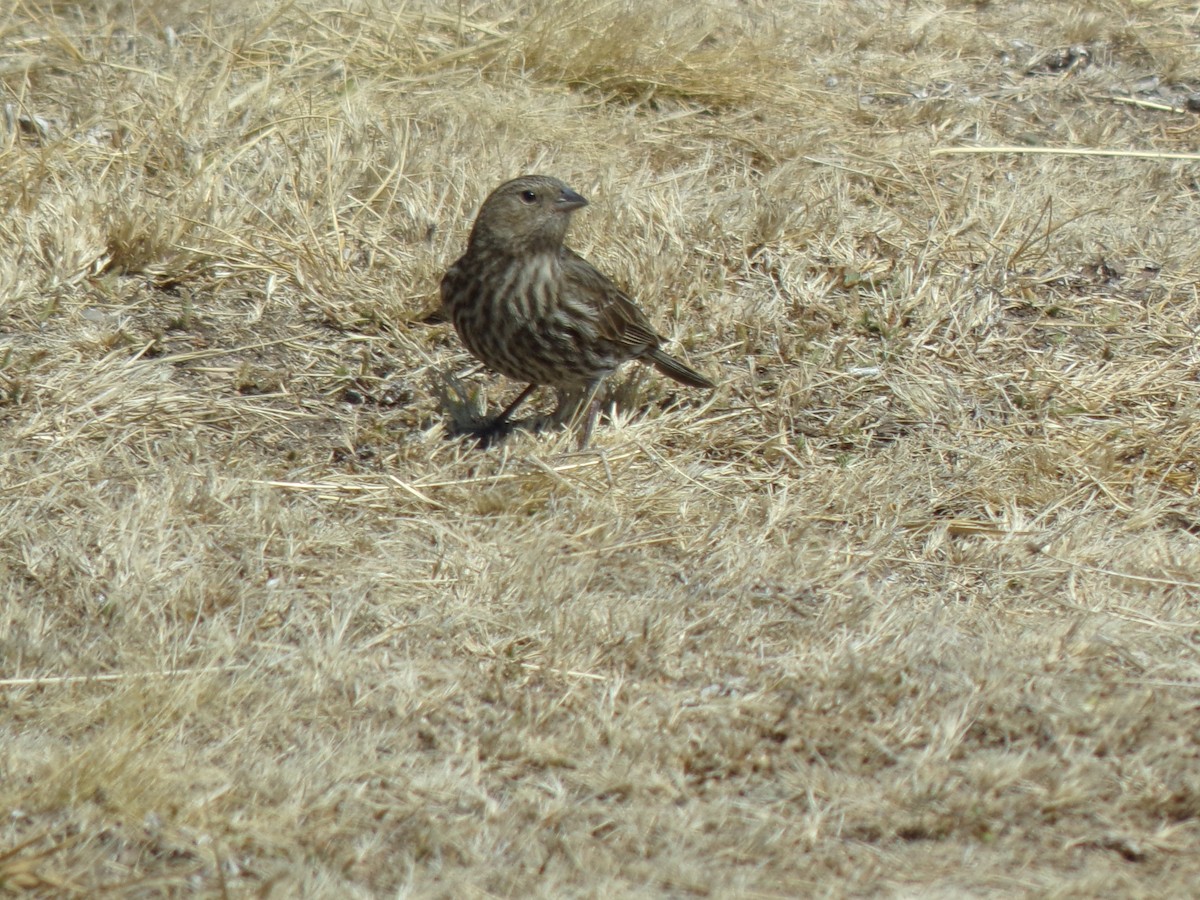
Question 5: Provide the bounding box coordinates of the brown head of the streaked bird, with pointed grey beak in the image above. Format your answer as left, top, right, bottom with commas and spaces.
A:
469, 175, 588, 253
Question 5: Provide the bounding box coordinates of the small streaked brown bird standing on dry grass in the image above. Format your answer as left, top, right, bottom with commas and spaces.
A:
442, 175, 716, 445
